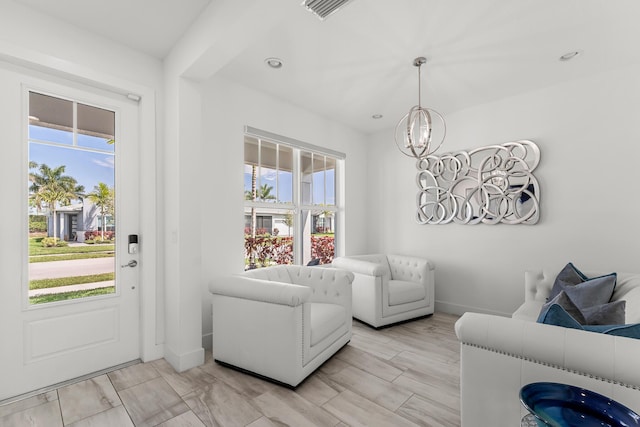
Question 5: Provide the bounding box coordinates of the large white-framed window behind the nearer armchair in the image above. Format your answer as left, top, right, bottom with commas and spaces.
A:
244, 128, 344, 269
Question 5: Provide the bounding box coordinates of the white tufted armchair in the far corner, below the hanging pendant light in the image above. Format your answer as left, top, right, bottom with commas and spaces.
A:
332, 254, 434, 328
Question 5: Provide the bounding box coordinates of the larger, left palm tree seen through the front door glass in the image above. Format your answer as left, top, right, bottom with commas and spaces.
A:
29, 162, 84, 244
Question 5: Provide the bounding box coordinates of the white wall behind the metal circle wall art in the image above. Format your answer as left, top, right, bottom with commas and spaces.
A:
368, 66, 640, 315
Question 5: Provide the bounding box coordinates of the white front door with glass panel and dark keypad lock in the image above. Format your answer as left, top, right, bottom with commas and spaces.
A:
0, 62, 142, 400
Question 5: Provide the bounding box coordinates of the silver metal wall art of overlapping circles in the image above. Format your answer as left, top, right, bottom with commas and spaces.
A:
416, 140, 540, 224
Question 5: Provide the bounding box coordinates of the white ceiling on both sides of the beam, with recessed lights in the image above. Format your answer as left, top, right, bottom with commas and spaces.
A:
16, 0, 640, 133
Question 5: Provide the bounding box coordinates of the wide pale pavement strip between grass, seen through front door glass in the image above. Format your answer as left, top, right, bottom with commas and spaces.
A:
29, 258, 115, 280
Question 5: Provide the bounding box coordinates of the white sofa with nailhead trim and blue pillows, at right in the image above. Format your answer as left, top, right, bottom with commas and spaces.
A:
455, 270, 640, 427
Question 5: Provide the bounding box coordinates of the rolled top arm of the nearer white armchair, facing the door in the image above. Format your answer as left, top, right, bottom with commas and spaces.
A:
209, 275, 311, 307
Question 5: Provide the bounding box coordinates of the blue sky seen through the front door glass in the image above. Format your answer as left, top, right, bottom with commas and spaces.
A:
29, 126, 115, 192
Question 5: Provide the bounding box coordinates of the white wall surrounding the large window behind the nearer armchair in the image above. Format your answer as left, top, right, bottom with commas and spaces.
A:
200, 73, 370, 346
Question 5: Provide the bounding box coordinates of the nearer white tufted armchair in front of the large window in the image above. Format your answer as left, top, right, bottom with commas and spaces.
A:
209, 265, 353, 387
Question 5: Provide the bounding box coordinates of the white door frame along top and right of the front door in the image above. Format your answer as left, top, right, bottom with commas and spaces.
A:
0, 42, 164, 400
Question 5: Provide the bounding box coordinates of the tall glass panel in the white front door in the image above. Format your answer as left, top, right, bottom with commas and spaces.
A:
28, 92, 116, 304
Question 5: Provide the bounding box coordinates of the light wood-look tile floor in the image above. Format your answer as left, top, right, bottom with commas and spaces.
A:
0, 313, 460, 427
